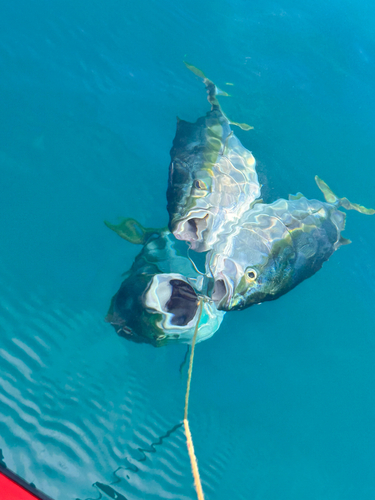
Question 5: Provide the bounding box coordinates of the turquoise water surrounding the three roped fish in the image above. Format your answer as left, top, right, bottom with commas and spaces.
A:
0, 0, 375, 500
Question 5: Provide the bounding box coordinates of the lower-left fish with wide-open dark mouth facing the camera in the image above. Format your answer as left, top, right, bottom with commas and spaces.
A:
106, 219, 225, 347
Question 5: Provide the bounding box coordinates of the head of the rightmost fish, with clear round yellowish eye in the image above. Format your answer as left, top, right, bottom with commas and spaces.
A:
207, 223, 295, 311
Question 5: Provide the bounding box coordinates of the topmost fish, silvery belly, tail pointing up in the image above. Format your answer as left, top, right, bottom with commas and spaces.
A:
167, 63, 261, 252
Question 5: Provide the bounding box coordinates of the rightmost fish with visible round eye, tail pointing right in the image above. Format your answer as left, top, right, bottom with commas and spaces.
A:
206, 176, 375, 311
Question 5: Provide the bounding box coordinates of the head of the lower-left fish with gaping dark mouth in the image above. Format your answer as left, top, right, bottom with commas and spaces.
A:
106, 272, 225, 347
